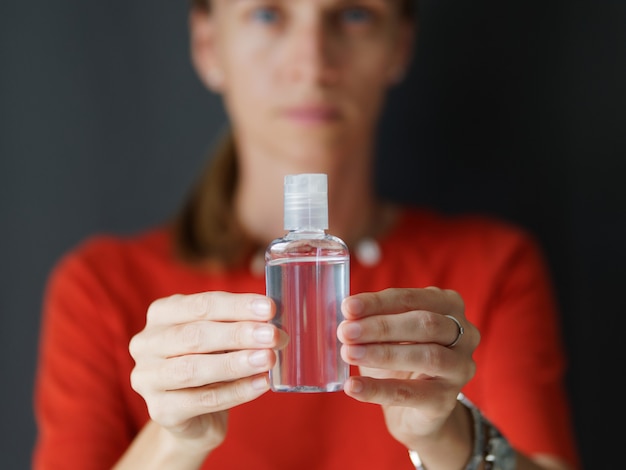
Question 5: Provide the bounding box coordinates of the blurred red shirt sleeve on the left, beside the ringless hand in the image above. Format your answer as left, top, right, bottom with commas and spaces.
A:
33, 242, 132, 470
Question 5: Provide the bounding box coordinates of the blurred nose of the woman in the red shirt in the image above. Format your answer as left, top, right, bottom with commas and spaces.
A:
286, 18, 338, 85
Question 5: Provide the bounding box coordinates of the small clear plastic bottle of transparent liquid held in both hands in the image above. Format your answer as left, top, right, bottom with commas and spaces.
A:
265, 173, 350, 392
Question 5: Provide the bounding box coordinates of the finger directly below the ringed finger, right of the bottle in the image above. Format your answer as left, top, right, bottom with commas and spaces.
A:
341, 343, 473, 382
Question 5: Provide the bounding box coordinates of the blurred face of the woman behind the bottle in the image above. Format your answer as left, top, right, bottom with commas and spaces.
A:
192, 0, 411, 163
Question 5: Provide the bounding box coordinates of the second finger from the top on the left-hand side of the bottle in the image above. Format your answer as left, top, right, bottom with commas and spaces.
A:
129, 321, 286, 359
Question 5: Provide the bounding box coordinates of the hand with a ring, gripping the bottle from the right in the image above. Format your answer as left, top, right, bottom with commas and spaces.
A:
338, 287, 480, 451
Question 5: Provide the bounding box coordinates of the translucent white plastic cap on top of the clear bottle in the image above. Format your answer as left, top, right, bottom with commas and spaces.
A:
284, 173, 328, 230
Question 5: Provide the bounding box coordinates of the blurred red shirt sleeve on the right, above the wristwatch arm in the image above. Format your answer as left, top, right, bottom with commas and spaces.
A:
477, 234, 579, 468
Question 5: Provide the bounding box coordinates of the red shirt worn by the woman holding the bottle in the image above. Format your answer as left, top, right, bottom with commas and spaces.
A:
33, 210, 578, 470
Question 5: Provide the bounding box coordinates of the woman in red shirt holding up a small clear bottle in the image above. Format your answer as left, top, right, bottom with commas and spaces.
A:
34, 0, 578, 470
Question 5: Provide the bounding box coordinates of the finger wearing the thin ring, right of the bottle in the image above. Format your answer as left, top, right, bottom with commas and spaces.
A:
337, 310, 461, 346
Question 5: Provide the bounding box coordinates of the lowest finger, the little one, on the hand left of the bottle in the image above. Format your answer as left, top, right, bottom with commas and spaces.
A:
147, 374, 269, 428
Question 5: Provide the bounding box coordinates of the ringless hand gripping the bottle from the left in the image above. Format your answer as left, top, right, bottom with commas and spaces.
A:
129, 292, 287, 455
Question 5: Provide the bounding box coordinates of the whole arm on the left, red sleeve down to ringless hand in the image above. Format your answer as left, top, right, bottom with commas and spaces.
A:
33, 248, 280, 470
